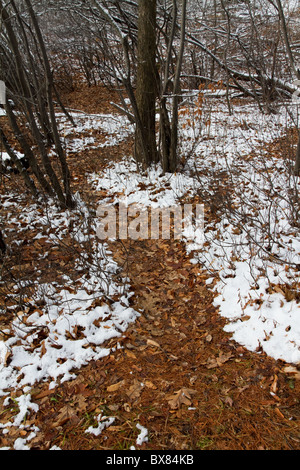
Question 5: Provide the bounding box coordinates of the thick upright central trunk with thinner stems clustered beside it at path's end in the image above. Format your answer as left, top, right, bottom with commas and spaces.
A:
92, 0, 187, 172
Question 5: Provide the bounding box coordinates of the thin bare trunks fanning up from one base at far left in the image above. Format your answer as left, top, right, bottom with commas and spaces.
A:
0, 0, 74, 208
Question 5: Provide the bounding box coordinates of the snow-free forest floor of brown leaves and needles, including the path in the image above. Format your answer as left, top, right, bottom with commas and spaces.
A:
0, 85, 300, 450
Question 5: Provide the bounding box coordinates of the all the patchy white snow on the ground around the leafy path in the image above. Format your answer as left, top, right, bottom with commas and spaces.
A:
0, 94, 300, 448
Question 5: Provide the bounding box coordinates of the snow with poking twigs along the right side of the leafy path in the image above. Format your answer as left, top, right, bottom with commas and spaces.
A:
178, 99, 300, 363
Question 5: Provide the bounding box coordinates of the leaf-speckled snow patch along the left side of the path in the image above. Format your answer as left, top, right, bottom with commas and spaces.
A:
0, 190, 139, 450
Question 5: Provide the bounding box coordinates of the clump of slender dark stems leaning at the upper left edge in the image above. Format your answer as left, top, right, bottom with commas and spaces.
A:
0, 0, 74, 208
